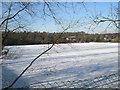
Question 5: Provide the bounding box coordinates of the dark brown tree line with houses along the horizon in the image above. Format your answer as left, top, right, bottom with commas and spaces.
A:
2, 31, 119, 45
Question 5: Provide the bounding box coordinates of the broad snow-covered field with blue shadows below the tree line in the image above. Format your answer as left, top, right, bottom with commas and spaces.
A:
1, 43, 118, 87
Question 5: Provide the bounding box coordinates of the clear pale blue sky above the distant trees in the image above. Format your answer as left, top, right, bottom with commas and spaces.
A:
3, 2, 118, 33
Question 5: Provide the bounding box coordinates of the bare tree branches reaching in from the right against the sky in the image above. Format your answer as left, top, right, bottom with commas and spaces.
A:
93, 3, 120, 31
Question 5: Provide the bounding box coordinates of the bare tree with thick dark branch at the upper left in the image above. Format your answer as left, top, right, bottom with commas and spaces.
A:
0, 2, 30, 49
